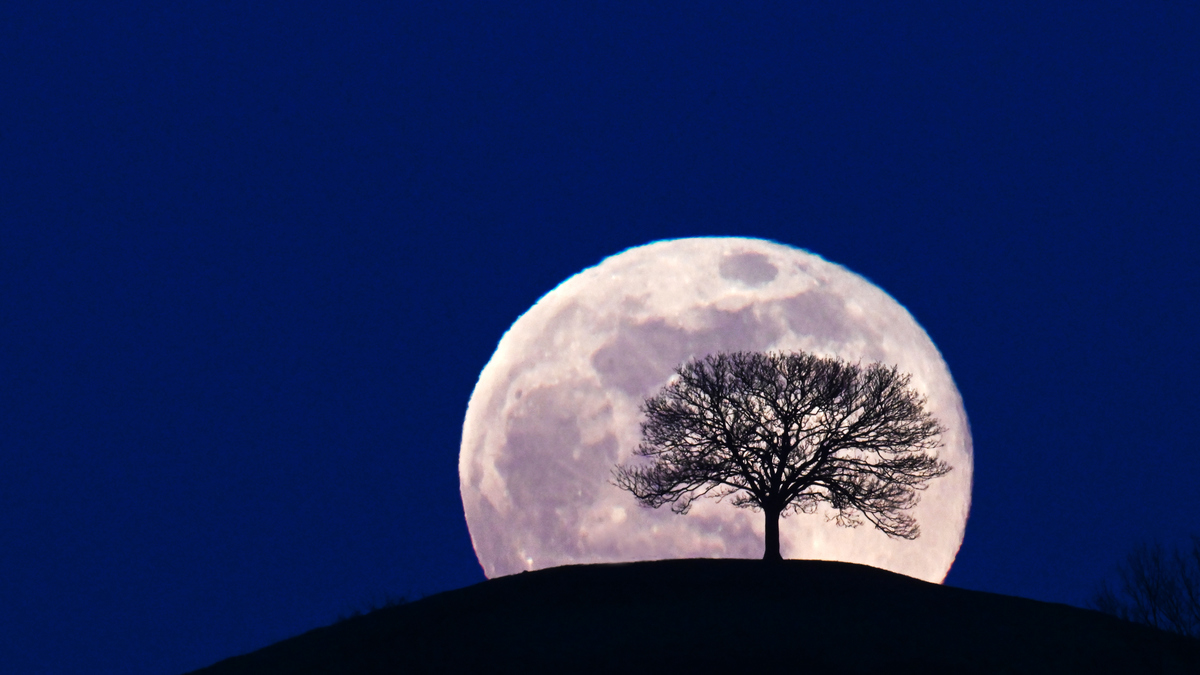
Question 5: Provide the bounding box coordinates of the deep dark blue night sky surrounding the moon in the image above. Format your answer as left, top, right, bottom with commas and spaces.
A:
0, 0, 1200, 675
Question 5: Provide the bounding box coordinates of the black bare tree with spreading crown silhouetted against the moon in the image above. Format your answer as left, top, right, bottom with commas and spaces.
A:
613, 352, 950, 560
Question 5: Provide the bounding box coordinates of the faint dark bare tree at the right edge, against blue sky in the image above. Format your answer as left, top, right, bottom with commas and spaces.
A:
1088, 536, 1200, 638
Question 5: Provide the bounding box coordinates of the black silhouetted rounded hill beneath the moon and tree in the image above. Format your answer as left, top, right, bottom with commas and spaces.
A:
187, 560, 1200, 675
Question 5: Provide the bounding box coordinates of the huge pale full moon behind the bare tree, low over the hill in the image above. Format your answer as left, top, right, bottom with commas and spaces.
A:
458, 238, 972, 583
